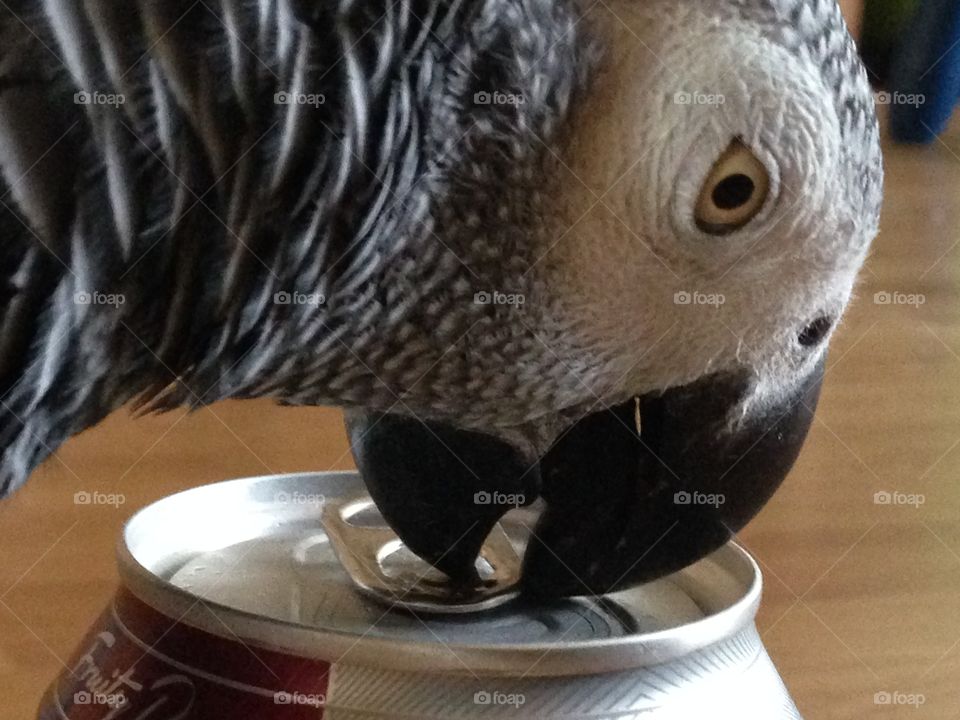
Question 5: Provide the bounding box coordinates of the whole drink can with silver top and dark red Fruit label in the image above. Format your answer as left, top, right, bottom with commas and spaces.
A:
38, 473, 800, 720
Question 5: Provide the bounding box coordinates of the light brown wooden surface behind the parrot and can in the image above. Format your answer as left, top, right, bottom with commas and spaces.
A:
0, 116, 960, 720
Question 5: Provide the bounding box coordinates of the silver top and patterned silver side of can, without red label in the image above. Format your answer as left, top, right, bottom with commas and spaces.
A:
109, 473, 800, 720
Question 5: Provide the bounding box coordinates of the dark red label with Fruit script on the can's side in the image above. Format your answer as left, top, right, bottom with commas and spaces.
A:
38, 590, 330, 720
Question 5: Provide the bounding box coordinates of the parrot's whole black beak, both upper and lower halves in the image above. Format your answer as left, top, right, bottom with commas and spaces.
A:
348, 362, 823, 598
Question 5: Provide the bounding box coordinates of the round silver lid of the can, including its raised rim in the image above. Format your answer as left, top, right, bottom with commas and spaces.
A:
119, 473, 761, 676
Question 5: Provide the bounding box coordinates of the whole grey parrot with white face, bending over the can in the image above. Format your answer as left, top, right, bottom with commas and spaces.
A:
0, 0, 882, 597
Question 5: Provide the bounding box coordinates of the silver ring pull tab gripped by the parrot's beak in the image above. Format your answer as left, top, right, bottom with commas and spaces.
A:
321, 497, 521, 615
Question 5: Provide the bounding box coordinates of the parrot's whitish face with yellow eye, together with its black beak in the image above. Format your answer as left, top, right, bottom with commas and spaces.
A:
349, 0, 882, 597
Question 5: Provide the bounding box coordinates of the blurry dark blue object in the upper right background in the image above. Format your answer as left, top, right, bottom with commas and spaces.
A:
880, 0, 960, 143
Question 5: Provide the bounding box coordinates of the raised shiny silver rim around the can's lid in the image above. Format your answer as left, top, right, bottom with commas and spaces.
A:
117, 472, 763, 677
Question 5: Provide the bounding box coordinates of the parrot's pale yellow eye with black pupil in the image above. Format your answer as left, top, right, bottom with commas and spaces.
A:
695, 140, 770, 235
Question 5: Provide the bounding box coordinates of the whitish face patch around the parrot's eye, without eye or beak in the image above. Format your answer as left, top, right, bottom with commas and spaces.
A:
536, 0, 880, 420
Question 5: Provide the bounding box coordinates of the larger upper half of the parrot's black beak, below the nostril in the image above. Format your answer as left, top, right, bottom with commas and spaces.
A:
523, 360, 824, 598
